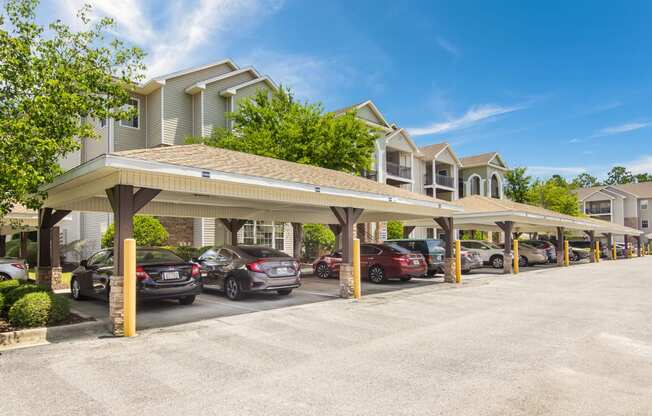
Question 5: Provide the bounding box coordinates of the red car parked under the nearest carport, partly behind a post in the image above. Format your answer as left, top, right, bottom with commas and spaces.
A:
312, 244, 428, 283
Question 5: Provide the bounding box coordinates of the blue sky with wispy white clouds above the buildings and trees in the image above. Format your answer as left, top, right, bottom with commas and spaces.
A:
40, 0, 652, 176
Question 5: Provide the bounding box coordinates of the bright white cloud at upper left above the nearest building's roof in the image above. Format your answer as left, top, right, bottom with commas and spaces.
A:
58, 0, 281, 78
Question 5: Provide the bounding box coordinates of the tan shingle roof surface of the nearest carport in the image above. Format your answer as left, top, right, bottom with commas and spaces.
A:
115, 144, 454, 205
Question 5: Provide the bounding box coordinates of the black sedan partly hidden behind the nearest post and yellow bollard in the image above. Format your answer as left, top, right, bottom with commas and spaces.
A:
70, 248, 202, 305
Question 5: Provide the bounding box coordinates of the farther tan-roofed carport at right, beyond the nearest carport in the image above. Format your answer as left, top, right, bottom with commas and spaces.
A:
409, 195, 601, 274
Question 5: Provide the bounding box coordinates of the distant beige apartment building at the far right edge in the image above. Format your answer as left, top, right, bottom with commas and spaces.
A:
576, 182, 652, 241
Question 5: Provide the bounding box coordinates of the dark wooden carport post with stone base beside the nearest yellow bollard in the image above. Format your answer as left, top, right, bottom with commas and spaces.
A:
106, 185, 160, 336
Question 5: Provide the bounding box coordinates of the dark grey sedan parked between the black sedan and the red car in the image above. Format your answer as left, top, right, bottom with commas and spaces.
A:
196, 245, 301, 300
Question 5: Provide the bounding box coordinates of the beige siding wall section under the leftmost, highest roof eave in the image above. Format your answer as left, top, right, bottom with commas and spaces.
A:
163, 64, 232, 144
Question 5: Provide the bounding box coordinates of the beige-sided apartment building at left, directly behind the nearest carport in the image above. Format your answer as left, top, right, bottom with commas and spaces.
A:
61, 60, 292, 256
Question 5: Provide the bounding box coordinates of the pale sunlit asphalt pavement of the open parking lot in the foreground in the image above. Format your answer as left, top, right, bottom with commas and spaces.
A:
6, 257, 652, 416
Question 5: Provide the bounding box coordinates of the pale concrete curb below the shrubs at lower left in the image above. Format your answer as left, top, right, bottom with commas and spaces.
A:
0, 321, 109, 351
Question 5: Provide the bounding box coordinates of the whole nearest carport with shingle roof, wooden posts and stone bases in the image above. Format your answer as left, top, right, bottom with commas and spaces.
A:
38, 145, 461, 334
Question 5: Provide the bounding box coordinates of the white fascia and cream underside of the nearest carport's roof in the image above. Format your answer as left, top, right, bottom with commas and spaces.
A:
42, 155, 462, 224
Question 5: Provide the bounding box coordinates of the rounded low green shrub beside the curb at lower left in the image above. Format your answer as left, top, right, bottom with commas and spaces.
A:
9, 292, 70, 328
